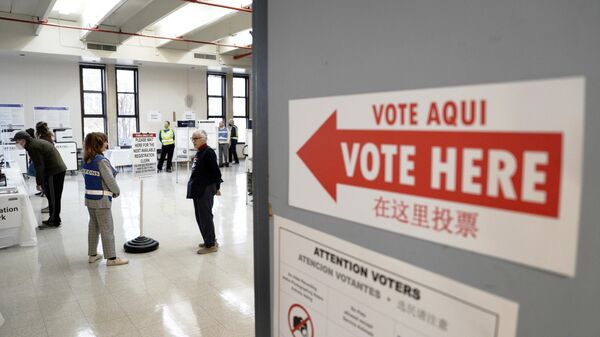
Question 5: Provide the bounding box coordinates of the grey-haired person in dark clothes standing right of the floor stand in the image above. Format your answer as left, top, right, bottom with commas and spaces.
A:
187, 130, 223, 254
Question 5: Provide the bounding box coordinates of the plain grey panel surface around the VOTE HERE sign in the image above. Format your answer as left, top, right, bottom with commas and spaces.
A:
268, 0, 600, 337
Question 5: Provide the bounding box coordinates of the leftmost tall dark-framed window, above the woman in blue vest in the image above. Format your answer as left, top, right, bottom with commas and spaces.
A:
79, 65, 106, 138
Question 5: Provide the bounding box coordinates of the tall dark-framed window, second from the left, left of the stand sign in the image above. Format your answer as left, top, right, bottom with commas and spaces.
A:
116, 68, 139, 146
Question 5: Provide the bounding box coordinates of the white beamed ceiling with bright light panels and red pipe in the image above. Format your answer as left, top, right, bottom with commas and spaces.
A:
0, 0, 252, 65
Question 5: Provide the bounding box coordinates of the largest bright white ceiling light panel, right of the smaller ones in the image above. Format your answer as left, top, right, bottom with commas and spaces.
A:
154, 3, 235, 37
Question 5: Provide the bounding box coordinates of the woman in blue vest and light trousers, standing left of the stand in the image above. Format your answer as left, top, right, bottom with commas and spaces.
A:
81, 132, 129, 266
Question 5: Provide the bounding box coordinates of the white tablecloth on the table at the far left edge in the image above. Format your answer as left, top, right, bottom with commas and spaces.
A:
0, 168, 37, 248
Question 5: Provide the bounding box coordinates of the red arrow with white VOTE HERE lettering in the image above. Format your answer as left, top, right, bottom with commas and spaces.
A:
297, 111, 562, 217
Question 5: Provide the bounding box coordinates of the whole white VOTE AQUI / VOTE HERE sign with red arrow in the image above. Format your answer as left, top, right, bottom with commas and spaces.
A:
289, 77, 585, 276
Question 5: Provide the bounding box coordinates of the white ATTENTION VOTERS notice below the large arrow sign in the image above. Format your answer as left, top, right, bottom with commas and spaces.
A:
273, 216, 518, 337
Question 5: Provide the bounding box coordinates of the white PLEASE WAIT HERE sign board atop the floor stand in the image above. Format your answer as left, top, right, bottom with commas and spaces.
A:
132, 133, 156, 178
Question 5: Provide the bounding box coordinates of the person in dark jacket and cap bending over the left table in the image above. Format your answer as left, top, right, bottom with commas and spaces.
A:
13, 131, 67, 229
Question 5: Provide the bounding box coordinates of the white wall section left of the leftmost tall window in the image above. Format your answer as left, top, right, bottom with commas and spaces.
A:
0, 55, 81, 146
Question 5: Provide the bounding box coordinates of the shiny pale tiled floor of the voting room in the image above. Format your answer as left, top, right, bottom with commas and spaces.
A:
0, 163, 254, 337
